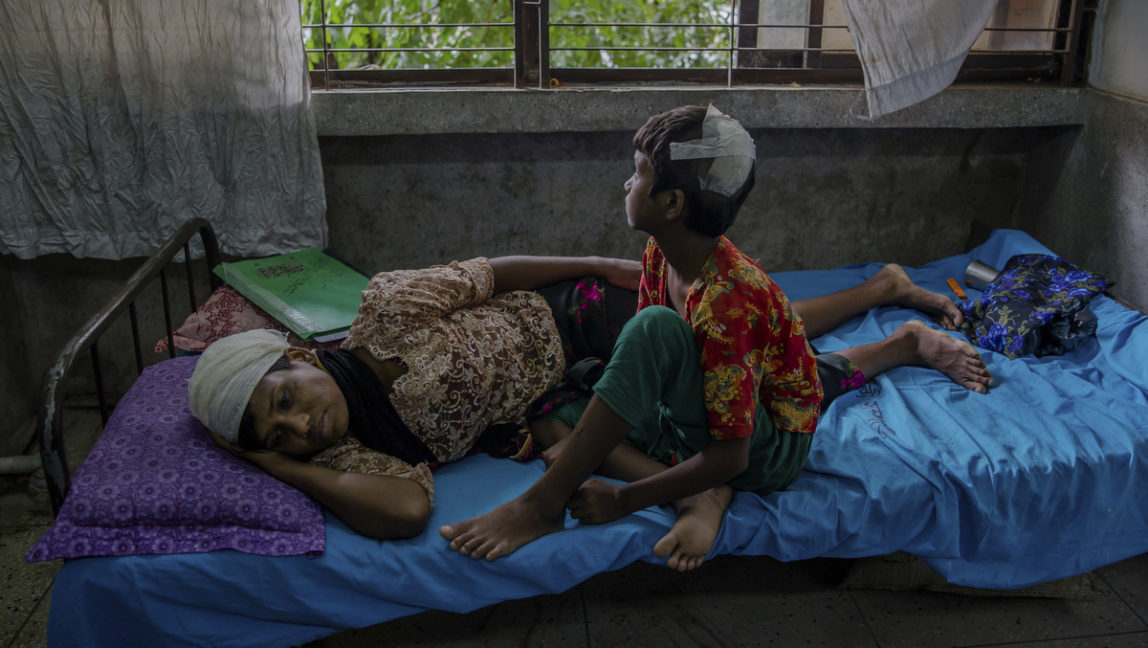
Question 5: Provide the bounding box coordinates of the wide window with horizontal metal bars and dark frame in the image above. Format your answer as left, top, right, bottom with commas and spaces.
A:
301, 0, 1095, 90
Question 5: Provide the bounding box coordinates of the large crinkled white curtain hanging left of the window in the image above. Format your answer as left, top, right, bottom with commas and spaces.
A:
0, 0, 327, 259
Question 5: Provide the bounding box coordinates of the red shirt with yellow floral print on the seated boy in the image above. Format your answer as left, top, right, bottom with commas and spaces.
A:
638, 237, 822, 439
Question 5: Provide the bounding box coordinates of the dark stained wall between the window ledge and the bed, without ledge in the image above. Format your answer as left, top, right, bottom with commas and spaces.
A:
321, 128, 1073, 276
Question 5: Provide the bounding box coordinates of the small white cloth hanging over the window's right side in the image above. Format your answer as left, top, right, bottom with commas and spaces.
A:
844, 0, 998, 117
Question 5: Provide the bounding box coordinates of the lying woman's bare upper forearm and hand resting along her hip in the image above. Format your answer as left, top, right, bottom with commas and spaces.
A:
490, 256, 642, 293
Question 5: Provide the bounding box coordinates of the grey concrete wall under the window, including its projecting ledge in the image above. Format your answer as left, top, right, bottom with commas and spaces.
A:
313, 88, 1084, 271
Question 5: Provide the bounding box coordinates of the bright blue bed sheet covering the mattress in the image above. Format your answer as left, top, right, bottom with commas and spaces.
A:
48, 230, 1148, 646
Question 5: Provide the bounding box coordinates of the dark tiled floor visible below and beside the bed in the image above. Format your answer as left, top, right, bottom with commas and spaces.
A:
0, 466, 1148, 648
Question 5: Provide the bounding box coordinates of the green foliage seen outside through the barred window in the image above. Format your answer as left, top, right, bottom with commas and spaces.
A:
301, 0, 731, 69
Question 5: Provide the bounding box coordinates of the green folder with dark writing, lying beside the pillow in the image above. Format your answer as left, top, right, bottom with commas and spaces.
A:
214, 247, 369, 342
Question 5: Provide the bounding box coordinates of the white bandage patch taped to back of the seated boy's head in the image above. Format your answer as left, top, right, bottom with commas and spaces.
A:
669, 103, 758, 198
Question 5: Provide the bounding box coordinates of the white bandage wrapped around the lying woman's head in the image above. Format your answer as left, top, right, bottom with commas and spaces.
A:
187, 329, 290, 443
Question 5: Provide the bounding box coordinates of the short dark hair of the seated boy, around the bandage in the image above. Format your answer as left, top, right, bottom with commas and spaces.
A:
634, 106, 757, 237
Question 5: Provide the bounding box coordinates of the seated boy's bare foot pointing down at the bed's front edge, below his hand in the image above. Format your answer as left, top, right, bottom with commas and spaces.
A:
653, 486, 734, 571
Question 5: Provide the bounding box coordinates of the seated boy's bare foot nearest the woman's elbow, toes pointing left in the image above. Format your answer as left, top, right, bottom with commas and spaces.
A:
439, 496, 566, 561
